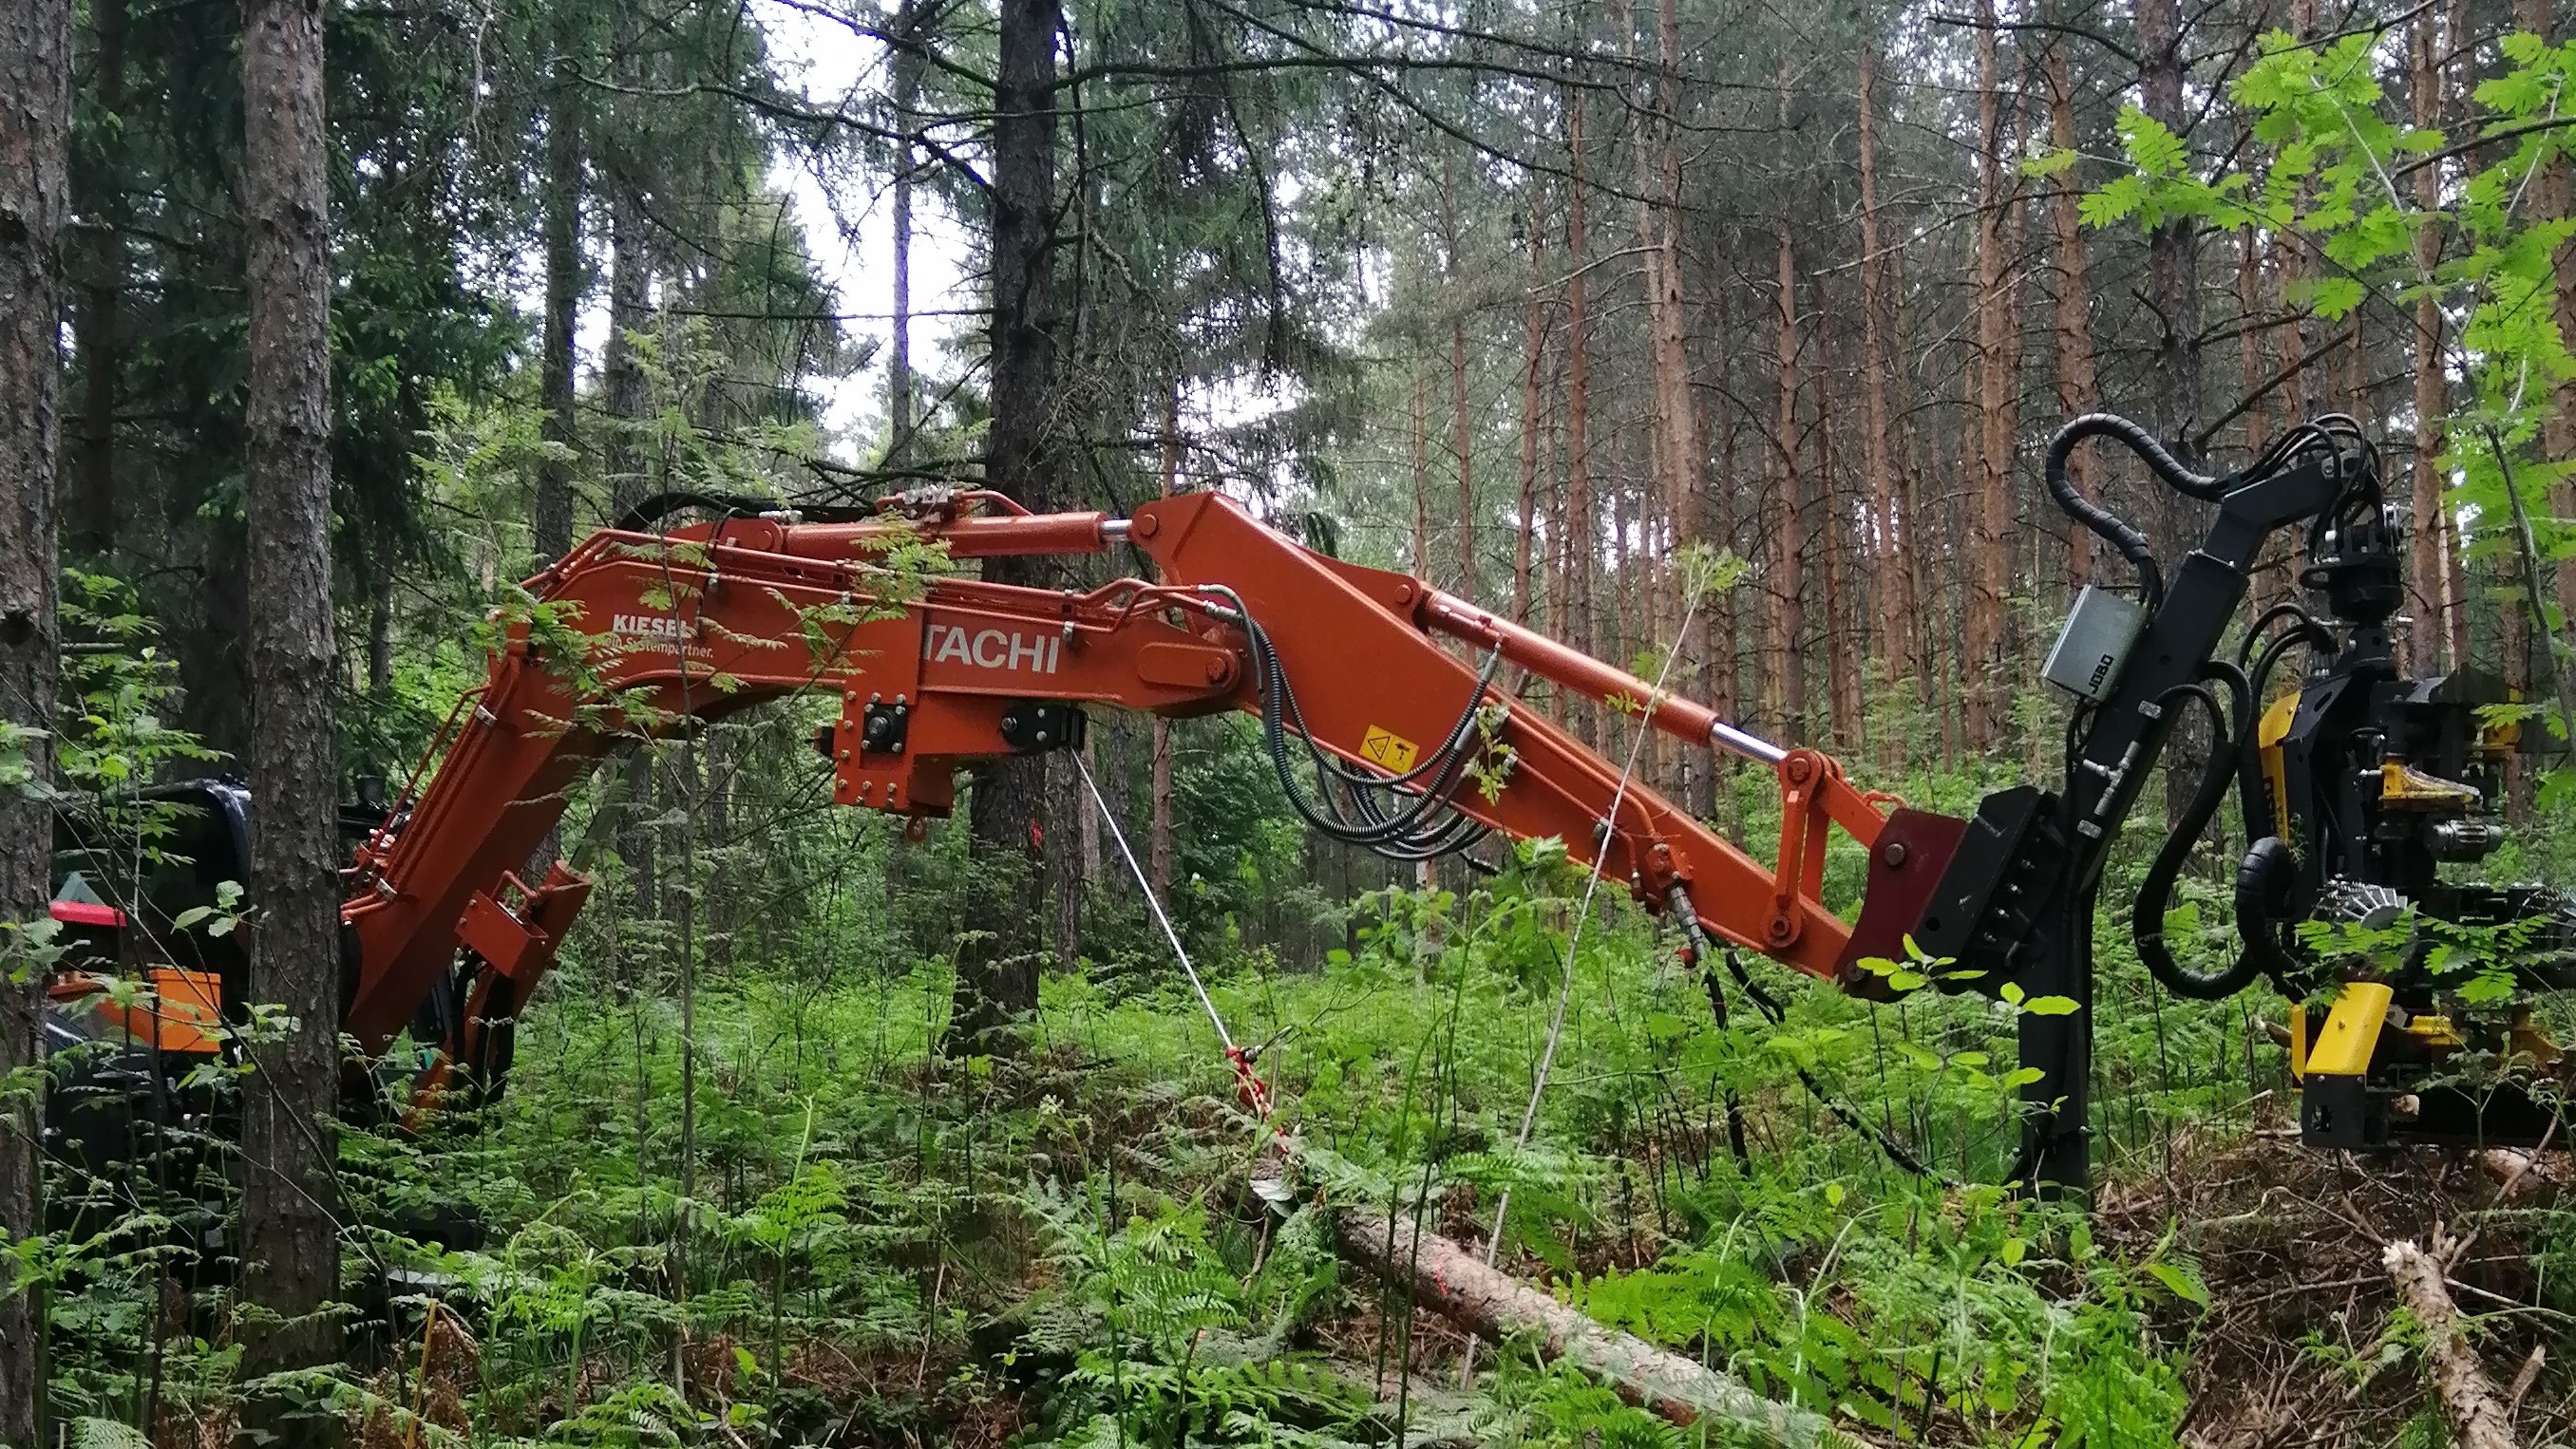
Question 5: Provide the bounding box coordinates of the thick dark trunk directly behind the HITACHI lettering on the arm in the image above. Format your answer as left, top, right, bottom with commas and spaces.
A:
948, 0, 1064, 1050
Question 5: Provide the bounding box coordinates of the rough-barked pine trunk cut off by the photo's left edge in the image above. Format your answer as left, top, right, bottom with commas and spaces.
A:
0, 0, 72, 1444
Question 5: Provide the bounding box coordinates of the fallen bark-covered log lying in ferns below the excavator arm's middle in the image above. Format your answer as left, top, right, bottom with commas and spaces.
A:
1335, 1210, 1837, 1444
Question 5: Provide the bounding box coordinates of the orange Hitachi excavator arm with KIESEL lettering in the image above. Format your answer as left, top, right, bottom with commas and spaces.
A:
343, 494, 1958, 1096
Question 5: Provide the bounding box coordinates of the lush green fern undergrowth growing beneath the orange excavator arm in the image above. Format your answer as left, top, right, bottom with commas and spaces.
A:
331, 859, 2246, 1444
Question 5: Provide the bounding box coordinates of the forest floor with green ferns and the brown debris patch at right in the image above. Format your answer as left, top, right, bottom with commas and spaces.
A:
57, 894, 2576, 1449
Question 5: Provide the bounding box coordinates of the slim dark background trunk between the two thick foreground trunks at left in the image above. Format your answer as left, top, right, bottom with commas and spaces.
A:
72, 0, 129, 558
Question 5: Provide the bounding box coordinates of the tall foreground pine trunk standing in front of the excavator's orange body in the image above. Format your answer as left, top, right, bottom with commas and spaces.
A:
242, 0, 340, 1441
